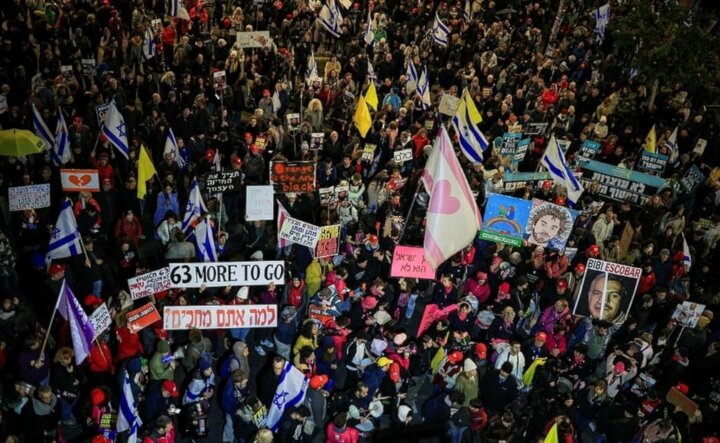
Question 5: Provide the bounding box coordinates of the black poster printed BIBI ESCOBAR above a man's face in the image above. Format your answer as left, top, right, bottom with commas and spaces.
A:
573, 258, 642, 323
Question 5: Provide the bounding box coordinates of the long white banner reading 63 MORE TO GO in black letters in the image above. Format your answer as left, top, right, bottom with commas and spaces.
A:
170, 260, 285, 288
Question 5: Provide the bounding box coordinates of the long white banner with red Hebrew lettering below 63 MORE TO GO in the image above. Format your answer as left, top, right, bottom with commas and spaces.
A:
163, 305, 277, 331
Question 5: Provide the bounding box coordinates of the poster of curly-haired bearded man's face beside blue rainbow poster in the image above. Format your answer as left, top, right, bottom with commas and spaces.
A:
523, 198, 577, 251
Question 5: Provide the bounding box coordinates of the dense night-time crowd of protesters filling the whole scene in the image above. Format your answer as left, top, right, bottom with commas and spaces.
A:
0, 0, 720, 443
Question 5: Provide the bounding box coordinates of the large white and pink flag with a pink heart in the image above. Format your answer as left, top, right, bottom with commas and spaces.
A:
421, 127, 481, 269
